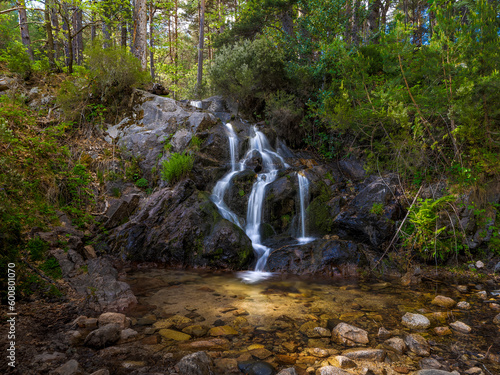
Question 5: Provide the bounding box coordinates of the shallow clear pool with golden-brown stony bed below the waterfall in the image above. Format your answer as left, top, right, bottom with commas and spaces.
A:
126, 269, 500, 374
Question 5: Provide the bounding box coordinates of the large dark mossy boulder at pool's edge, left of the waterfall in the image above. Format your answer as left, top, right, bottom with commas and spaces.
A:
109, 180, 253, 269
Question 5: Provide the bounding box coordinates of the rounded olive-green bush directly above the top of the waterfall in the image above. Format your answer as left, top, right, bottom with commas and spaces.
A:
209, 37, 285, 113
